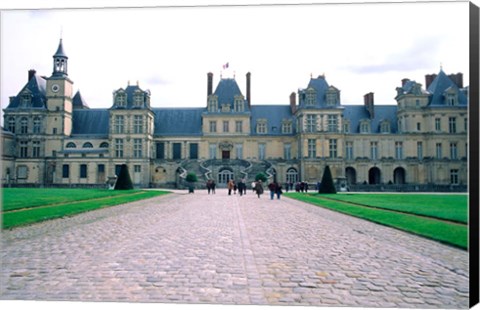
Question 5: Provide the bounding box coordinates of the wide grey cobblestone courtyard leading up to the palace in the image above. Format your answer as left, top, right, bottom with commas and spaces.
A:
0, 190, 469, 308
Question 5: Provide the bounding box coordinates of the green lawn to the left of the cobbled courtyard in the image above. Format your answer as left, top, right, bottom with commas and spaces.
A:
2, 189, 168, 229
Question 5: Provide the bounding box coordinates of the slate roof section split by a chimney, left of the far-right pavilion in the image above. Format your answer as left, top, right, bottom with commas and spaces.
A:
343, 105, 398, 133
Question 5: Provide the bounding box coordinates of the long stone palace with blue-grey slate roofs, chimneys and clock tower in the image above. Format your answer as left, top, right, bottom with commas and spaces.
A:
2, 40, 468, 190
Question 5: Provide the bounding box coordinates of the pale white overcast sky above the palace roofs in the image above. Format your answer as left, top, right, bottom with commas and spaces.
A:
0, 1, 469, 118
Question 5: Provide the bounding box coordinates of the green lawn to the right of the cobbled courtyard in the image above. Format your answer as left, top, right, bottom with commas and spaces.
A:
287, 193, 468, 249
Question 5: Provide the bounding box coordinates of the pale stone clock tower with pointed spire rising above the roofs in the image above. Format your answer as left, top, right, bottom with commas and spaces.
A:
45, 39, 73, 136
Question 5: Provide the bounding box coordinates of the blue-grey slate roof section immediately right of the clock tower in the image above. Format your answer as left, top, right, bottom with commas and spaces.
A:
72, 109, 109, 136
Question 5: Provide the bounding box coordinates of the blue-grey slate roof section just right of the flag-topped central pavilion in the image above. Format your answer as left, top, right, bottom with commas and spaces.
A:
250, 105, 296, 136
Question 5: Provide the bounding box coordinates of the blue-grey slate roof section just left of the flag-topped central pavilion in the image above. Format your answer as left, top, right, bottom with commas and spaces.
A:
152, 108, 206, 136
